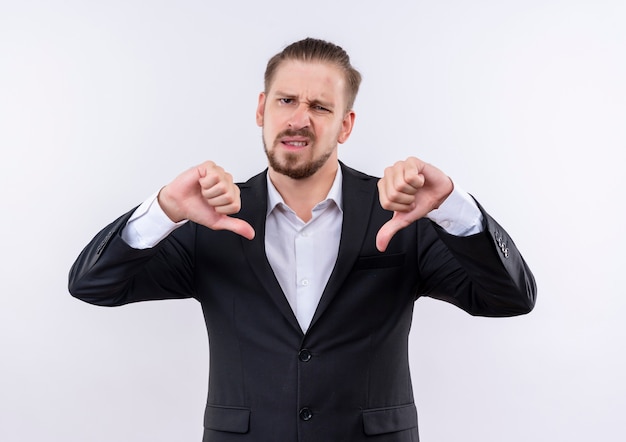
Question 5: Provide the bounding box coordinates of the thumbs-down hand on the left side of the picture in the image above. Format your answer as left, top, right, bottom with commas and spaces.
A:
158, 161, 254, 239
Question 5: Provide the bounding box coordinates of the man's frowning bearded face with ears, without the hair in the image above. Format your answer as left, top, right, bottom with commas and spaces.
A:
256, 60, 354, 179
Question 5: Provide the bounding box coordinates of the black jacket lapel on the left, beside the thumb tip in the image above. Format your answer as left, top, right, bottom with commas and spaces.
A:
237, 171, 302, 333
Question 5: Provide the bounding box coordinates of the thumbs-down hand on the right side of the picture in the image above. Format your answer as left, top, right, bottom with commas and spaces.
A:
376, 157, 454, 252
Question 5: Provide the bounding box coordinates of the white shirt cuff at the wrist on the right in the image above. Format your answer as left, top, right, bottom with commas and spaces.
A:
426, 185, 483, 236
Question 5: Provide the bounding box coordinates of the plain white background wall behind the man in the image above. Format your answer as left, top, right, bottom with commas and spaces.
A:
0, 0, 626, 442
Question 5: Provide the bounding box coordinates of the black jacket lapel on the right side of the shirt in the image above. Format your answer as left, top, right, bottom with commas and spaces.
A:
309, 163, 376, 330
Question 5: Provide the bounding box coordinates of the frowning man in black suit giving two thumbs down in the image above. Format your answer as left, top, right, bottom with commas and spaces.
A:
70, 39, 536, 442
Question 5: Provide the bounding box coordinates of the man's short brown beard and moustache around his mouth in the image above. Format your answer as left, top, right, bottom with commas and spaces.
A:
263, 129, 333, 180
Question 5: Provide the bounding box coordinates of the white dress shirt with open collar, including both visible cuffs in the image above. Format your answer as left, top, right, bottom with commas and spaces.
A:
122, 167, 483, 331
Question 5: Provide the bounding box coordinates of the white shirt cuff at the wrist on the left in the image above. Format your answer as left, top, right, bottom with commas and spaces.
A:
122, 192, 187, 249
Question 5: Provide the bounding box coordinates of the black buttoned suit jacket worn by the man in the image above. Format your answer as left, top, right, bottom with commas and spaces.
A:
70, 164, 536, 442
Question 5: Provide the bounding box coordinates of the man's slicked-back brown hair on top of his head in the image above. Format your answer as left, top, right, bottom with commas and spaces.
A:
265, 38, 361, 110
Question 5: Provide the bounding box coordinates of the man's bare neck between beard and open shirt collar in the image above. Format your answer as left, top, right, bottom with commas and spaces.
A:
269, 160, 339, 222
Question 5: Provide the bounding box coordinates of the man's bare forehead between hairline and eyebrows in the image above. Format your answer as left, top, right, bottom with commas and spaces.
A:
267, 60, 346, 101
